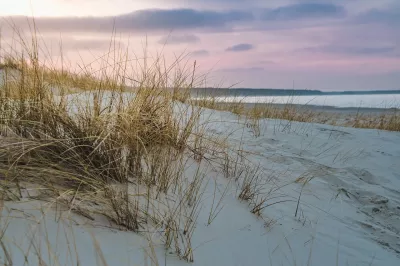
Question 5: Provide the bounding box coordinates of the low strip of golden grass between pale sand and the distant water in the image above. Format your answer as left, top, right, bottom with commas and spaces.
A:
192, 93, 400, 132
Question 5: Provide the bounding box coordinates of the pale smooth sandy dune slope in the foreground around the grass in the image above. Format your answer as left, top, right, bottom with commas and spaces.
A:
0, 104, 400, 266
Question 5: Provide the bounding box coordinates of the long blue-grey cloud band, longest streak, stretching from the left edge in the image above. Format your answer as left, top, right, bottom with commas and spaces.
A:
2, 9, 254, 32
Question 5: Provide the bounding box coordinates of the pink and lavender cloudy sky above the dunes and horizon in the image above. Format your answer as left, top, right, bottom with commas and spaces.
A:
0, 0, 400, 90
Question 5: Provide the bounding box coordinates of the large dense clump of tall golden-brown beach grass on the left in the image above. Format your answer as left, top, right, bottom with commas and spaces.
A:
0, 25, 215, 261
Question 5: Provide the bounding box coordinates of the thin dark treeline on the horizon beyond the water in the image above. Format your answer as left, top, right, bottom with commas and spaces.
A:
192, 88, 400, 96
